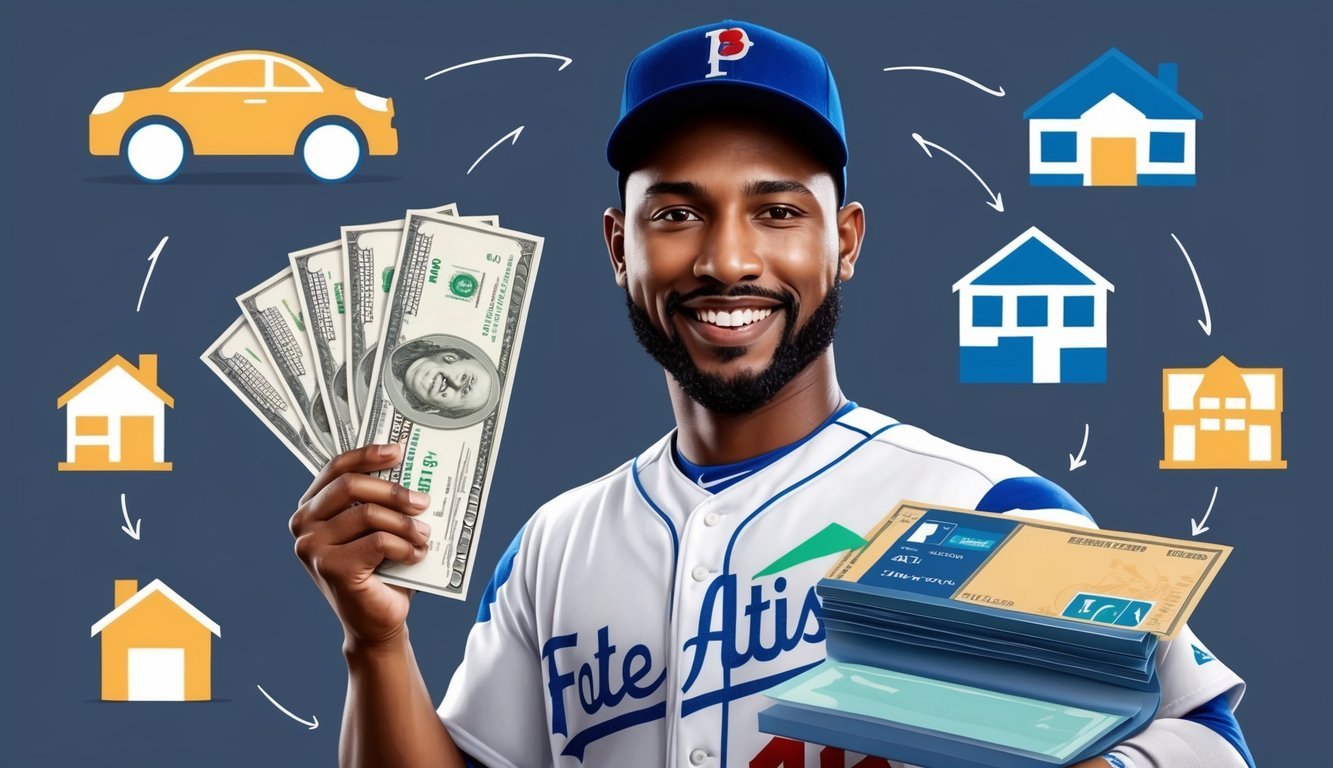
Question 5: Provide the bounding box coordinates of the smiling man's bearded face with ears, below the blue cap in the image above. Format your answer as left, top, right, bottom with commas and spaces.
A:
607, 117, 860, 412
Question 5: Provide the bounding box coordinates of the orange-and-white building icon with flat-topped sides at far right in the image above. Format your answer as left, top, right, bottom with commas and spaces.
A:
1158, 357, 1286, 469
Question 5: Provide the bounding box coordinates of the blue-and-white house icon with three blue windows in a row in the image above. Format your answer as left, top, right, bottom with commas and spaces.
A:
953, 227, 1116, 384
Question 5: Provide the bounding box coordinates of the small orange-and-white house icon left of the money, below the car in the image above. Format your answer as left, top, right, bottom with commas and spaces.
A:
56, 355, 176, 472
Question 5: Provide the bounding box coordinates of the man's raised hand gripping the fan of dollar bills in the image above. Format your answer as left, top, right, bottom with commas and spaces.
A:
291, 444, 431, 648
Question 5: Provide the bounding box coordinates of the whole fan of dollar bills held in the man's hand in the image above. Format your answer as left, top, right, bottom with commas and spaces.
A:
201, 204, 543, 600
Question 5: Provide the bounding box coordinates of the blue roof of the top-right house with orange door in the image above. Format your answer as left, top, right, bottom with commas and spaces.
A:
1022, 48, 1204, 120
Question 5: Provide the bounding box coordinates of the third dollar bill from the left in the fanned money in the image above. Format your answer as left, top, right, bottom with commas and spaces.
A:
287, 240, 356, 453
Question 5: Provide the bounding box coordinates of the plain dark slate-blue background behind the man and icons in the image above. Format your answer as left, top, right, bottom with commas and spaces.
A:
0, 0, 1333, 767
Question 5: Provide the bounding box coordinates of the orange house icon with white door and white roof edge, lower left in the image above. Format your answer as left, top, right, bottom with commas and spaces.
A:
92, 579, 223, 701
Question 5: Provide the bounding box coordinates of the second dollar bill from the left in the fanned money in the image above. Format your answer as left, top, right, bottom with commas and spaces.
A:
236, 267, 339, 456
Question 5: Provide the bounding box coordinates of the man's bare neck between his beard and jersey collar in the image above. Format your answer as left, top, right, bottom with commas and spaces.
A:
667, 347, 846, 465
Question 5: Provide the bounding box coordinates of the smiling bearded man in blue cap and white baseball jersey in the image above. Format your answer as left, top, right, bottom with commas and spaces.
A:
292, 21, 1248, 768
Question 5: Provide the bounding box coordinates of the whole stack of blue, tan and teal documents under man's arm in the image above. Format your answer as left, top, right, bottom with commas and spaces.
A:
760, 501, 1230, 768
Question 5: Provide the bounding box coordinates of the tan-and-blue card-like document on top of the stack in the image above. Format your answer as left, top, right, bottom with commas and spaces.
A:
828, 501, 1232, 639
